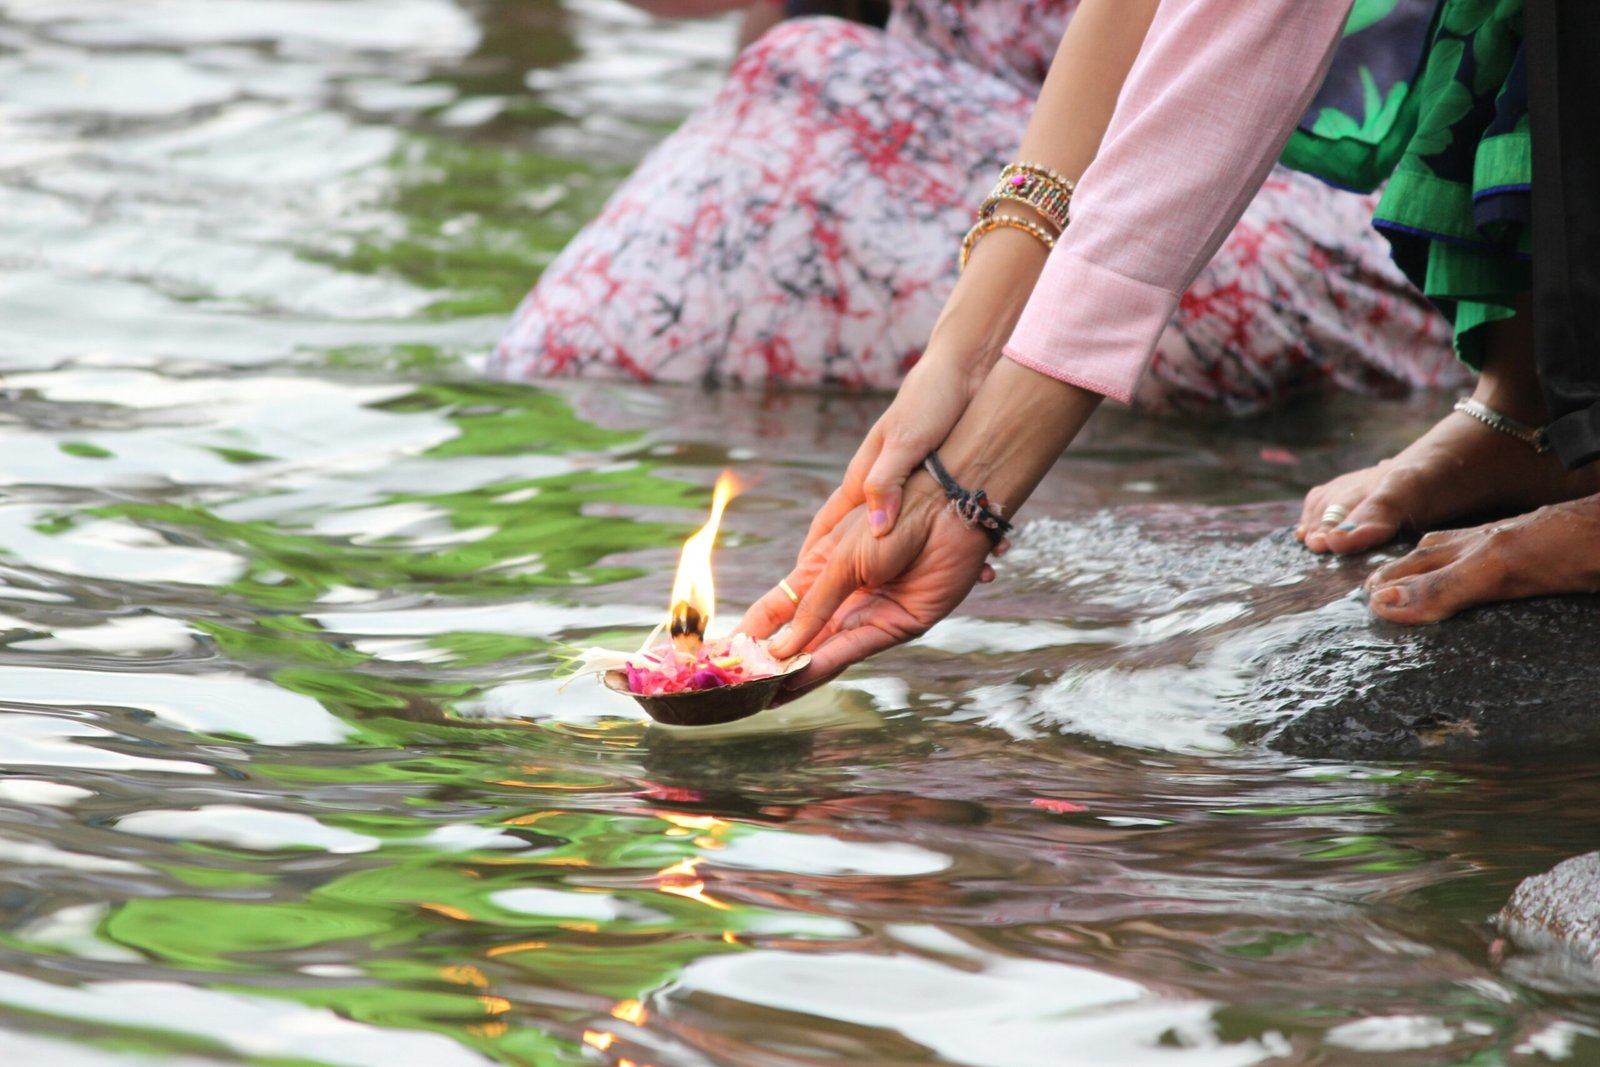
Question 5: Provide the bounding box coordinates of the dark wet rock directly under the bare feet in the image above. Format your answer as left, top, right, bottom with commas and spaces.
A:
1251, 597, 1600, 760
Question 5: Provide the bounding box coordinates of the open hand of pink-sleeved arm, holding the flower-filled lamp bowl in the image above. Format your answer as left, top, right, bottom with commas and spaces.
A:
738, 477, 992, 699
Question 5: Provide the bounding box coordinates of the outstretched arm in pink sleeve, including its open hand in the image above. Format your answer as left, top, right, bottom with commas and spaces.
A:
741, 0, 1350, 685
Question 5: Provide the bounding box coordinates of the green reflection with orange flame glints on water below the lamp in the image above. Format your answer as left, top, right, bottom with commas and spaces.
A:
81, 799, 787, 1064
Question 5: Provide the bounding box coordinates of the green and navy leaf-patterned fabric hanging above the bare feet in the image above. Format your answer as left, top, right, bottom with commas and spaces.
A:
1283, 0, 1533, 366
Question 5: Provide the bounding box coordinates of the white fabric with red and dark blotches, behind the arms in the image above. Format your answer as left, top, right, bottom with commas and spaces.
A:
490, 0, 1462, 413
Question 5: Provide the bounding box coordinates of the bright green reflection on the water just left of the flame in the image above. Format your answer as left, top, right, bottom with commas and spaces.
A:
81, 384, 684, 607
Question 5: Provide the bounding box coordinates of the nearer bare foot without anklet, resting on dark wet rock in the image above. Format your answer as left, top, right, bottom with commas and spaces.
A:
1366, 494, 1600, 622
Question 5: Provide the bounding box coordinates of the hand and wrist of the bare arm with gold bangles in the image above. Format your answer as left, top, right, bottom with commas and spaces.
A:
800, 346, 990, 560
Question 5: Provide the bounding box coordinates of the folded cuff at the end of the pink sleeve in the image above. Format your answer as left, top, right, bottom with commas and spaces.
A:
1005, 248, 1179, 403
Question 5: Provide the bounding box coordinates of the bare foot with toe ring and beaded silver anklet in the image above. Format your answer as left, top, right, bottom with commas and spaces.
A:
1294, 411, 1600, 553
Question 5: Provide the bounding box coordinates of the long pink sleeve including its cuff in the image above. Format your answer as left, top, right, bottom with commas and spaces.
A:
1005, 0, 1352, 403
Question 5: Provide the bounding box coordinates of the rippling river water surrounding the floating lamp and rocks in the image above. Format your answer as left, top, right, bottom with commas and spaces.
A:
0, 0, 1600, 1067
